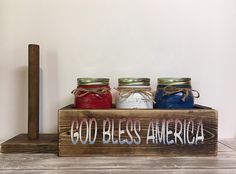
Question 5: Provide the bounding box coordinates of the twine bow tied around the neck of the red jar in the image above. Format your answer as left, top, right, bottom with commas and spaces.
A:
71, 87, 110, 97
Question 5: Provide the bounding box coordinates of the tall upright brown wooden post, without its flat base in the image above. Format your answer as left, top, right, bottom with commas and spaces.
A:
28, 44, 40, 139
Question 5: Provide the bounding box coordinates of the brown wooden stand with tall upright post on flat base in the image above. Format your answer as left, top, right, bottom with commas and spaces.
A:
1, 44, 58, 153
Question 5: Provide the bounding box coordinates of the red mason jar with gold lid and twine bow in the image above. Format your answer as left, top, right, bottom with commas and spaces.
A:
73, 78, 112, 109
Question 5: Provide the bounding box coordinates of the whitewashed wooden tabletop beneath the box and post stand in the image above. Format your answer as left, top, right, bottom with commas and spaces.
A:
0, 139, 236, 174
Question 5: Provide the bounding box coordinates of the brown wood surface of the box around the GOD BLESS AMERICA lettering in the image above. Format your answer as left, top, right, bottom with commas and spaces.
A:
59, 106, 218, 156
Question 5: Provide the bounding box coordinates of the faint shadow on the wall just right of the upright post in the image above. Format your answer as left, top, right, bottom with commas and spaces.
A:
39, 52, 59, 133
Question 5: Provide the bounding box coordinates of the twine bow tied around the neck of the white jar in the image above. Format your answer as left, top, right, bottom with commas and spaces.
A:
116, 87, 156, 103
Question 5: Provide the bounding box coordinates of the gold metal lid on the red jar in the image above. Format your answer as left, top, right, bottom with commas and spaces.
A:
77, 78, 109, 86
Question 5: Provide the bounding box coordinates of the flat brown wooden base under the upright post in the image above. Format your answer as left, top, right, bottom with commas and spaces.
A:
1, 134, 58, 153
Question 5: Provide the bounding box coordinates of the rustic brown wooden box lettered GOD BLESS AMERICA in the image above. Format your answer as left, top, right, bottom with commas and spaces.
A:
58, 106, 218, 156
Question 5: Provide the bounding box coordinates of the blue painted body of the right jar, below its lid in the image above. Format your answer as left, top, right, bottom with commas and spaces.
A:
155, 85, 194, 109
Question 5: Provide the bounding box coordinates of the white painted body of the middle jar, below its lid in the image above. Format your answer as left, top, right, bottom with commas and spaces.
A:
116, 86, 153, 109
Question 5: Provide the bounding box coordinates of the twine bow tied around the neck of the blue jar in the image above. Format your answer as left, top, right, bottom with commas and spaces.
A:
158, 86, 200, 101
